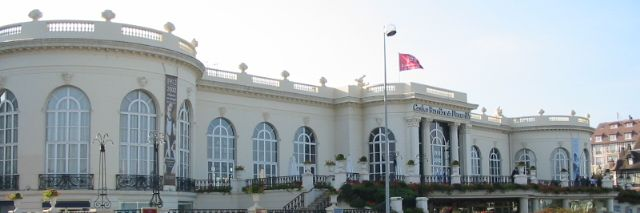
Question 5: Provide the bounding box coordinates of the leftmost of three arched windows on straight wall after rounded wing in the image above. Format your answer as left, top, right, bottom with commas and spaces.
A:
207, 118, 236, 180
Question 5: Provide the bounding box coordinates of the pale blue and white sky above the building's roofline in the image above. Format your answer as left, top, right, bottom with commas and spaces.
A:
0, 0, 640, 126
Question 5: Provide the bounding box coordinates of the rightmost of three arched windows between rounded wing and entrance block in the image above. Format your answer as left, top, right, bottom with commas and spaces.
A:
293, 126, 317, 174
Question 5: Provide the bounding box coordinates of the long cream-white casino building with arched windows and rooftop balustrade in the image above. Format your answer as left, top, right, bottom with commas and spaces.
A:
0, 11, 616, 211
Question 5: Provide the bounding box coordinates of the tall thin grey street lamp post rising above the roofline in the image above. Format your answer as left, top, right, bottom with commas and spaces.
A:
382, 24, 396, 213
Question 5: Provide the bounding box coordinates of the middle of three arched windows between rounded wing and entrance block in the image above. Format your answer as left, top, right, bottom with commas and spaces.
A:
253, 122, 278, 177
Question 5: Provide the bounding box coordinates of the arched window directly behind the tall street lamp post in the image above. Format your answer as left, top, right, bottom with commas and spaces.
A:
369, 127, 396, 180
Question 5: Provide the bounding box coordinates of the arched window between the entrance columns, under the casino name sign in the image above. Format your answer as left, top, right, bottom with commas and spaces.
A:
430, 122, 449, 176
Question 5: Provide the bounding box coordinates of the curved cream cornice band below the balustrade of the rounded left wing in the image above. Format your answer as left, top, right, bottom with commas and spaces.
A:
0, 38, 205, 77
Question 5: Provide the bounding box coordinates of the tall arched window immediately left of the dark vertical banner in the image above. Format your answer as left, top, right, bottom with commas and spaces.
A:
120, 90, 157, 175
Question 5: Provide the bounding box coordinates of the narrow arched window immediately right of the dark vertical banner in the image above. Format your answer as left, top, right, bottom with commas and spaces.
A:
177, 101, 191, 178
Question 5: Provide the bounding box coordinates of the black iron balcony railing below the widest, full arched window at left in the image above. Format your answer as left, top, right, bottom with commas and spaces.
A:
38, 174, 93, 190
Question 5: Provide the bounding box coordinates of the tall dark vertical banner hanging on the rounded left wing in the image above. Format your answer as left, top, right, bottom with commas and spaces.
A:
164, 75, 178, 185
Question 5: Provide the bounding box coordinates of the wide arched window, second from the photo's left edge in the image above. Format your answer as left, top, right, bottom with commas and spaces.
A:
46, 86, 91, 174
